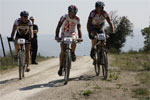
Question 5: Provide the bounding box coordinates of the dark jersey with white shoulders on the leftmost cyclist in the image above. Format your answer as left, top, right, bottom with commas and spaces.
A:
14, 18, 32, 35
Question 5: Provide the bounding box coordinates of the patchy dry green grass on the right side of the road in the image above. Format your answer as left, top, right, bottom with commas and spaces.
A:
109, 52, 150, 100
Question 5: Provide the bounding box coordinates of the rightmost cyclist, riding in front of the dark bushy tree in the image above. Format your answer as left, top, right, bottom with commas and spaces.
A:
87, 1, 114, 59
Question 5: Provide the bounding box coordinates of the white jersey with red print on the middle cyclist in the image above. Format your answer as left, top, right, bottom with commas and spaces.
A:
60, 14, 80, 37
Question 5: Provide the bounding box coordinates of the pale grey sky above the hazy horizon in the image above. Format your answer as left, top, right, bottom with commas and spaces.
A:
0, 0, 150, 36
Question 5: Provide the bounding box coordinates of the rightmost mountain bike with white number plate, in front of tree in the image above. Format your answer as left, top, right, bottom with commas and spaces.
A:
93, 33, 108, 79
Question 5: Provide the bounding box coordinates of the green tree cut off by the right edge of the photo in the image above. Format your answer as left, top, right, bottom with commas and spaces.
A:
141, 26, 150, 52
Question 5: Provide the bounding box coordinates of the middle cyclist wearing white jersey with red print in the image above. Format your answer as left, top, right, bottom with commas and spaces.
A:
55, 5, 82, 76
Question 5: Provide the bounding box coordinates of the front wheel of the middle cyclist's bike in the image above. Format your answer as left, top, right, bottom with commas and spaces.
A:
64, 50, 71, 84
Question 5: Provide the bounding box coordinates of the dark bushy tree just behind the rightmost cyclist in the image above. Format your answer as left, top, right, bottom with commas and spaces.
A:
105, 11, 133, 52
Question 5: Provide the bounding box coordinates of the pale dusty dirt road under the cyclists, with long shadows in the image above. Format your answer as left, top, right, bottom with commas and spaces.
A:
0, 56, 138, 100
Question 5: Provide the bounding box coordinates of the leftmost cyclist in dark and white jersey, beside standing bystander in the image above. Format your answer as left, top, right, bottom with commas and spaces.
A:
11, 11, 33, 72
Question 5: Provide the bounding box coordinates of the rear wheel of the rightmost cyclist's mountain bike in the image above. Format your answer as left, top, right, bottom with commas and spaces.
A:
94, 52, 100, 76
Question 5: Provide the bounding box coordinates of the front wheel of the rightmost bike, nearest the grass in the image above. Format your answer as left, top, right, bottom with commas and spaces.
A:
102, 51, 108, 80
